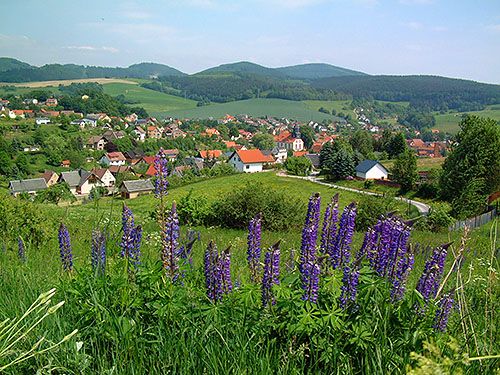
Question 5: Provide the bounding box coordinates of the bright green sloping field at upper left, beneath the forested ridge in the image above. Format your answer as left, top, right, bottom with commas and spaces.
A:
103, 83, 196, 115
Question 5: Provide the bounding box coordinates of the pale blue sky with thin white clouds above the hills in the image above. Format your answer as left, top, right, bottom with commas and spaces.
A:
0, 0, 500, 84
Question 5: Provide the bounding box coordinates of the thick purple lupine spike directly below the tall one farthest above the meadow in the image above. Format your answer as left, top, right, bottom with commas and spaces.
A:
161, 202, 179, 282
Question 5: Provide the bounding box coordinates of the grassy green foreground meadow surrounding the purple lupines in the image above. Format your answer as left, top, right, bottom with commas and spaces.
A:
0, 172, 500, 374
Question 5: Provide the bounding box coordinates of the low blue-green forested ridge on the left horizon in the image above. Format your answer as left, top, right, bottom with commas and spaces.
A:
0, 58, 185, 83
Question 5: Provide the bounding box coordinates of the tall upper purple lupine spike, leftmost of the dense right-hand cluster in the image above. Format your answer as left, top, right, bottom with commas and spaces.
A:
300, 193, 321, 272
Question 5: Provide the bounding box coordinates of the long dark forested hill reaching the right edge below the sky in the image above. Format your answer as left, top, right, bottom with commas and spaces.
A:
312, 76, 500, 111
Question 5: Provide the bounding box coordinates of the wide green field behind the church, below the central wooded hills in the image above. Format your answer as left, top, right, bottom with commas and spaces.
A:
156, 99, 339, 122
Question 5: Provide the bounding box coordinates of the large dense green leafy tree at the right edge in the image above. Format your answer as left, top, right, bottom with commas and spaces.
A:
439, 116, 500, 212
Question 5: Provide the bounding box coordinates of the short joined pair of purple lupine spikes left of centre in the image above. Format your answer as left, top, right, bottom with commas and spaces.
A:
205, 241, 232, 302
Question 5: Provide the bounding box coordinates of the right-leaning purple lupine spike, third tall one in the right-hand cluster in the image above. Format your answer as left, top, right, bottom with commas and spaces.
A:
329, 201, 356, 269
